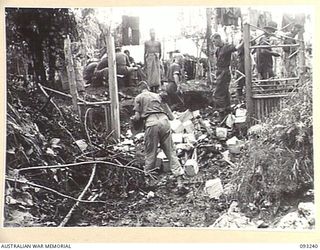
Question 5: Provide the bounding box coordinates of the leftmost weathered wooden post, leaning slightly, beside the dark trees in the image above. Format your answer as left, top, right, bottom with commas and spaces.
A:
64, 36, 80, 116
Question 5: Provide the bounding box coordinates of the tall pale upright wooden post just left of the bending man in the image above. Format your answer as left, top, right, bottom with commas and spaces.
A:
107, 30, 120, 140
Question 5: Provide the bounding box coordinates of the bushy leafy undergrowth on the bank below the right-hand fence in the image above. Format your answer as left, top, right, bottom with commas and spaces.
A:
234, 78, 314, 211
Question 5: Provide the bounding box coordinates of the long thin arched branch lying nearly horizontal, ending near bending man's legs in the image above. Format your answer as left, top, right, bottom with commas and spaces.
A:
17, 161, 144, 173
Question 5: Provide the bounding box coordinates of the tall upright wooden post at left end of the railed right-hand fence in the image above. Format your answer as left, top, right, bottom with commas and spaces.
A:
243, 23, 254, 125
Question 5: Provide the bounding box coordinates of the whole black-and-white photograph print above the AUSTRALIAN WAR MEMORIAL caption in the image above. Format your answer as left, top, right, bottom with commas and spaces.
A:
2, 5, 316, 229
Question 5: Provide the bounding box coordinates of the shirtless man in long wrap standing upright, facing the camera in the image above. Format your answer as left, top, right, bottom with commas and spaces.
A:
144, 29, 161, 92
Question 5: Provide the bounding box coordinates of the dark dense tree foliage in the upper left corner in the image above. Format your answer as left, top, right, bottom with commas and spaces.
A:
5, 8, 77, 86
